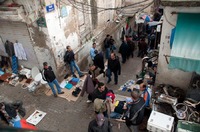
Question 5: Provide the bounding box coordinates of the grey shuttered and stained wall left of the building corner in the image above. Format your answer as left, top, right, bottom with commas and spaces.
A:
1, 0, 55, 69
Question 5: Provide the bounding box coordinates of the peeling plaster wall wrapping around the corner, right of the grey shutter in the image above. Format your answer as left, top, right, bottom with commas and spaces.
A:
0, 0, 122, 75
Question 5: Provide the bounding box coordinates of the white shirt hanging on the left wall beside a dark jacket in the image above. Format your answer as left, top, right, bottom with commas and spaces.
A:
14, 41, 27, 60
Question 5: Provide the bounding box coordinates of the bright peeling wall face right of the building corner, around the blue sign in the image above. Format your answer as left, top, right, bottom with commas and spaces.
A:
41, 0, 121, 75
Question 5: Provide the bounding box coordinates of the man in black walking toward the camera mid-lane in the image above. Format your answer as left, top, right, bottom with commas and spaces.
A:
107, 53, 121, 85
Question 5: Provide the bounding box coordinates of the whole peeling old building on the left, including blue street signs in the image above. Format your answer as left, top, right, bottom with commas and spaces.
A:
0, 0, 123, 75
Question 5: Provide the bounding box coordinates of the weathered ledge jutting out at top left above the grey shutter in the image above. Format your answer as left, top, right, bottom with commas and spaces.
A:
0, 6, 25, 21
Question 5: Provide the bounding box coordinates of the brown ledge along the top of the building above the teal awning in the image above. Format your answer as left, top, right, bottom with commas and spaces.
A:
161, 0, 200, 7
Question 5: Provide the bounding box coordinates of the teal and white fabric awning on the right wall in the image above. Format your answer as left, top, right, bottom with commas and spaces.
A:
169, 13, 200, 73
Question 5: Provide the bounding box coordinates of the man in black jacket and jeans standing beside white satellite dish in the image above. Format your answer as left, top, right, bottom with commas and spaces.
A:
42, 62, 64, 97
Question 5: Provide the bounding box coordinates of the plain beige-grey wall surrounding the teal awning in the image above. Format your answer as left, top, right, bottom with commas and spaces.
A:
156, 7, 200, 90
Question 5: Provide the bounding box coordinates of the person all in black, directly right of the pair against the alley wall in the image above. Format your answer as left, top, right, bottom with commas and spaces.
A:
119, 39, 129, 63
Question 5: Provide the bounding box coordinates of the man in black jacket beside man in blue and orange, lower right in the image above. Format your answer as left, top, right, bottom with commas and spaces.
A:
126, 89, 145, 132
